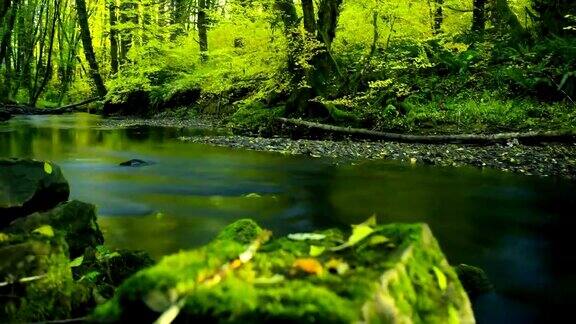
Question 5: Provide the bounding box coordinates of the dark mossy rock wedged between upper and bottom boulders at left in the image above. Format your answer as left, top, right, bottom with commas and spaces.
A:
6, 200, 104, 258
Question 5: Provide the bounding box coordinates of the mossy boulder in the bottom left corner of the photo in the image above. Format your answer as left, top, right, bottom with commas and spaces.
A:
0, 227, 80, 323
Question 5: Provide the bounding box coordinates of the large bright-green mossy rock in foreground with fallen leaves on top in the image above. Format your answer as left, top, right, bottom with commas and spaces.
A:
93, 220, 474, 323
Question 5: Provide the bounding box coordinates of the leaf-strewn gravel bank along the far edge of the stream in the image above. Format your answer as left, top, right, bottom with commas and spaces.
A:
102, 117, 576, 180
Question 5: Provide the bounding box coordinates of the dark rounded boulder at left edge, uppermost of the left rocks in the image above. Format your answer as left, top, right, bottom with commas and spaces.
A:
0, 159, 70, 224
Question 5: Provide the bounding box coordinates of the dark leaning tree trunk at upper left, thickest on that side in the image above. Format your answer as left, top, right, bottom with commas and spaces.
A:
75, 0, 106, 97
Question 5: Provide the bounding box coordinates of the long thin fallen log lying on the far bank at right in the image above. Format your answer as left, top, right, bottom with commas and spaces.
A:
278, 118, 576, 144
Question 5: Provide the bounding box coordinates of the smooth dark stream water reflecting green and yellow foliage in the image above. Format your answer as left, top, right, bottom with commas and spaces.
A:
0, 114, 576, 323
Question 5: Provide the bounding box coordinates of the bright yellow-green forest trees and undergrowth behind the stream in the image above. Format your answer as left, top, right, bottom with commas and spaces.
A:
0, 0, 576, 129
